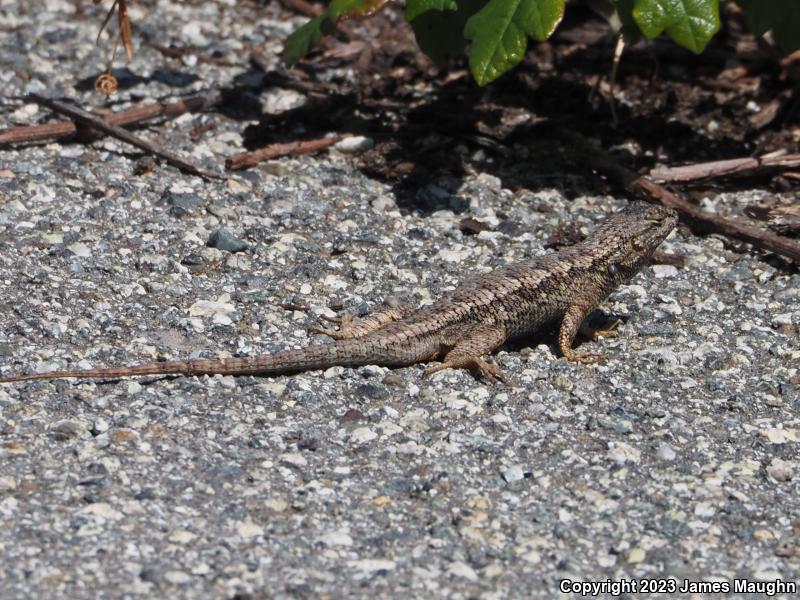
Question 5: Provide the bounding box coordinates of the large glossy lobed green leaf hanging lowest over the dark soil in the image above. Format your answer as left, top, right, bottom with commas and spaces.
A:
464, 0, 564, 85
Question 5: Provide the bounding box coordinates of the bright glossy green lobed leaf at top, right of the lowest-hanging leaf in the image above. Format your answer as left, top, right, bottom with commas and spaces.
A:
633, 0, 719, 54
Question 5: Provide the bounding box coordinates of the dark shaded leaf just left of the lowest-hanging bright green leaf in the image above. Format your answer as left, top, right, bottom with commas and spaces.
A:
406, 0, 486, 68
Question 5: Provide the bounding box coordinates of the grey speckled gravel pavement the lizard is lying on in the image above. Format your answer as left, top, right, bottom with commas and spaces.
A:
0, 0, 800, 598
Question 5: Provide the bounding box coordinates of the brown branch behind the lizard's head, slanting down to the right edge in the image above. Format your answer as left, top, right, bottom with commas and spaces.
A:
581, 152, 800, 263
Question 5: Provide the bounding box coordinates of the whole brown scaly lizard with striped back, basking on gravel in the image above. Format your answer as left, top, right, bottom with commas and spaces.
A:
0, 203, 678, 383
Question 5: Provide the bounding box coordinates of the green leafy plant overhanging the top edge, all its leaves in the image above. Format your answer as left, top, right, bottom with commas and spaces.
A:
283, 0, 800, 85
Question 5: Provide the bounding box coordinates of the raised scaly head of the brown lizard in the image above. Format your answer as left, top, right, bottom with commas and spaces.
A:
593, 202, 678, 283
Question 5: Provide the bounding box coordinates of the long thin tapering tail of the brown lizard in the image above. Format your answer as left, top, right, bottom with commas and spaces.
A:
0, 340, 415, 383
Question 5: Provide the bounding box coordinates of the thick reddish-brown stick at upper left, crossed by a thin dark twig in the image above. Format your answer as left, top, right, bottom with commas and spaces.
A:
0, 90, 223, 145
